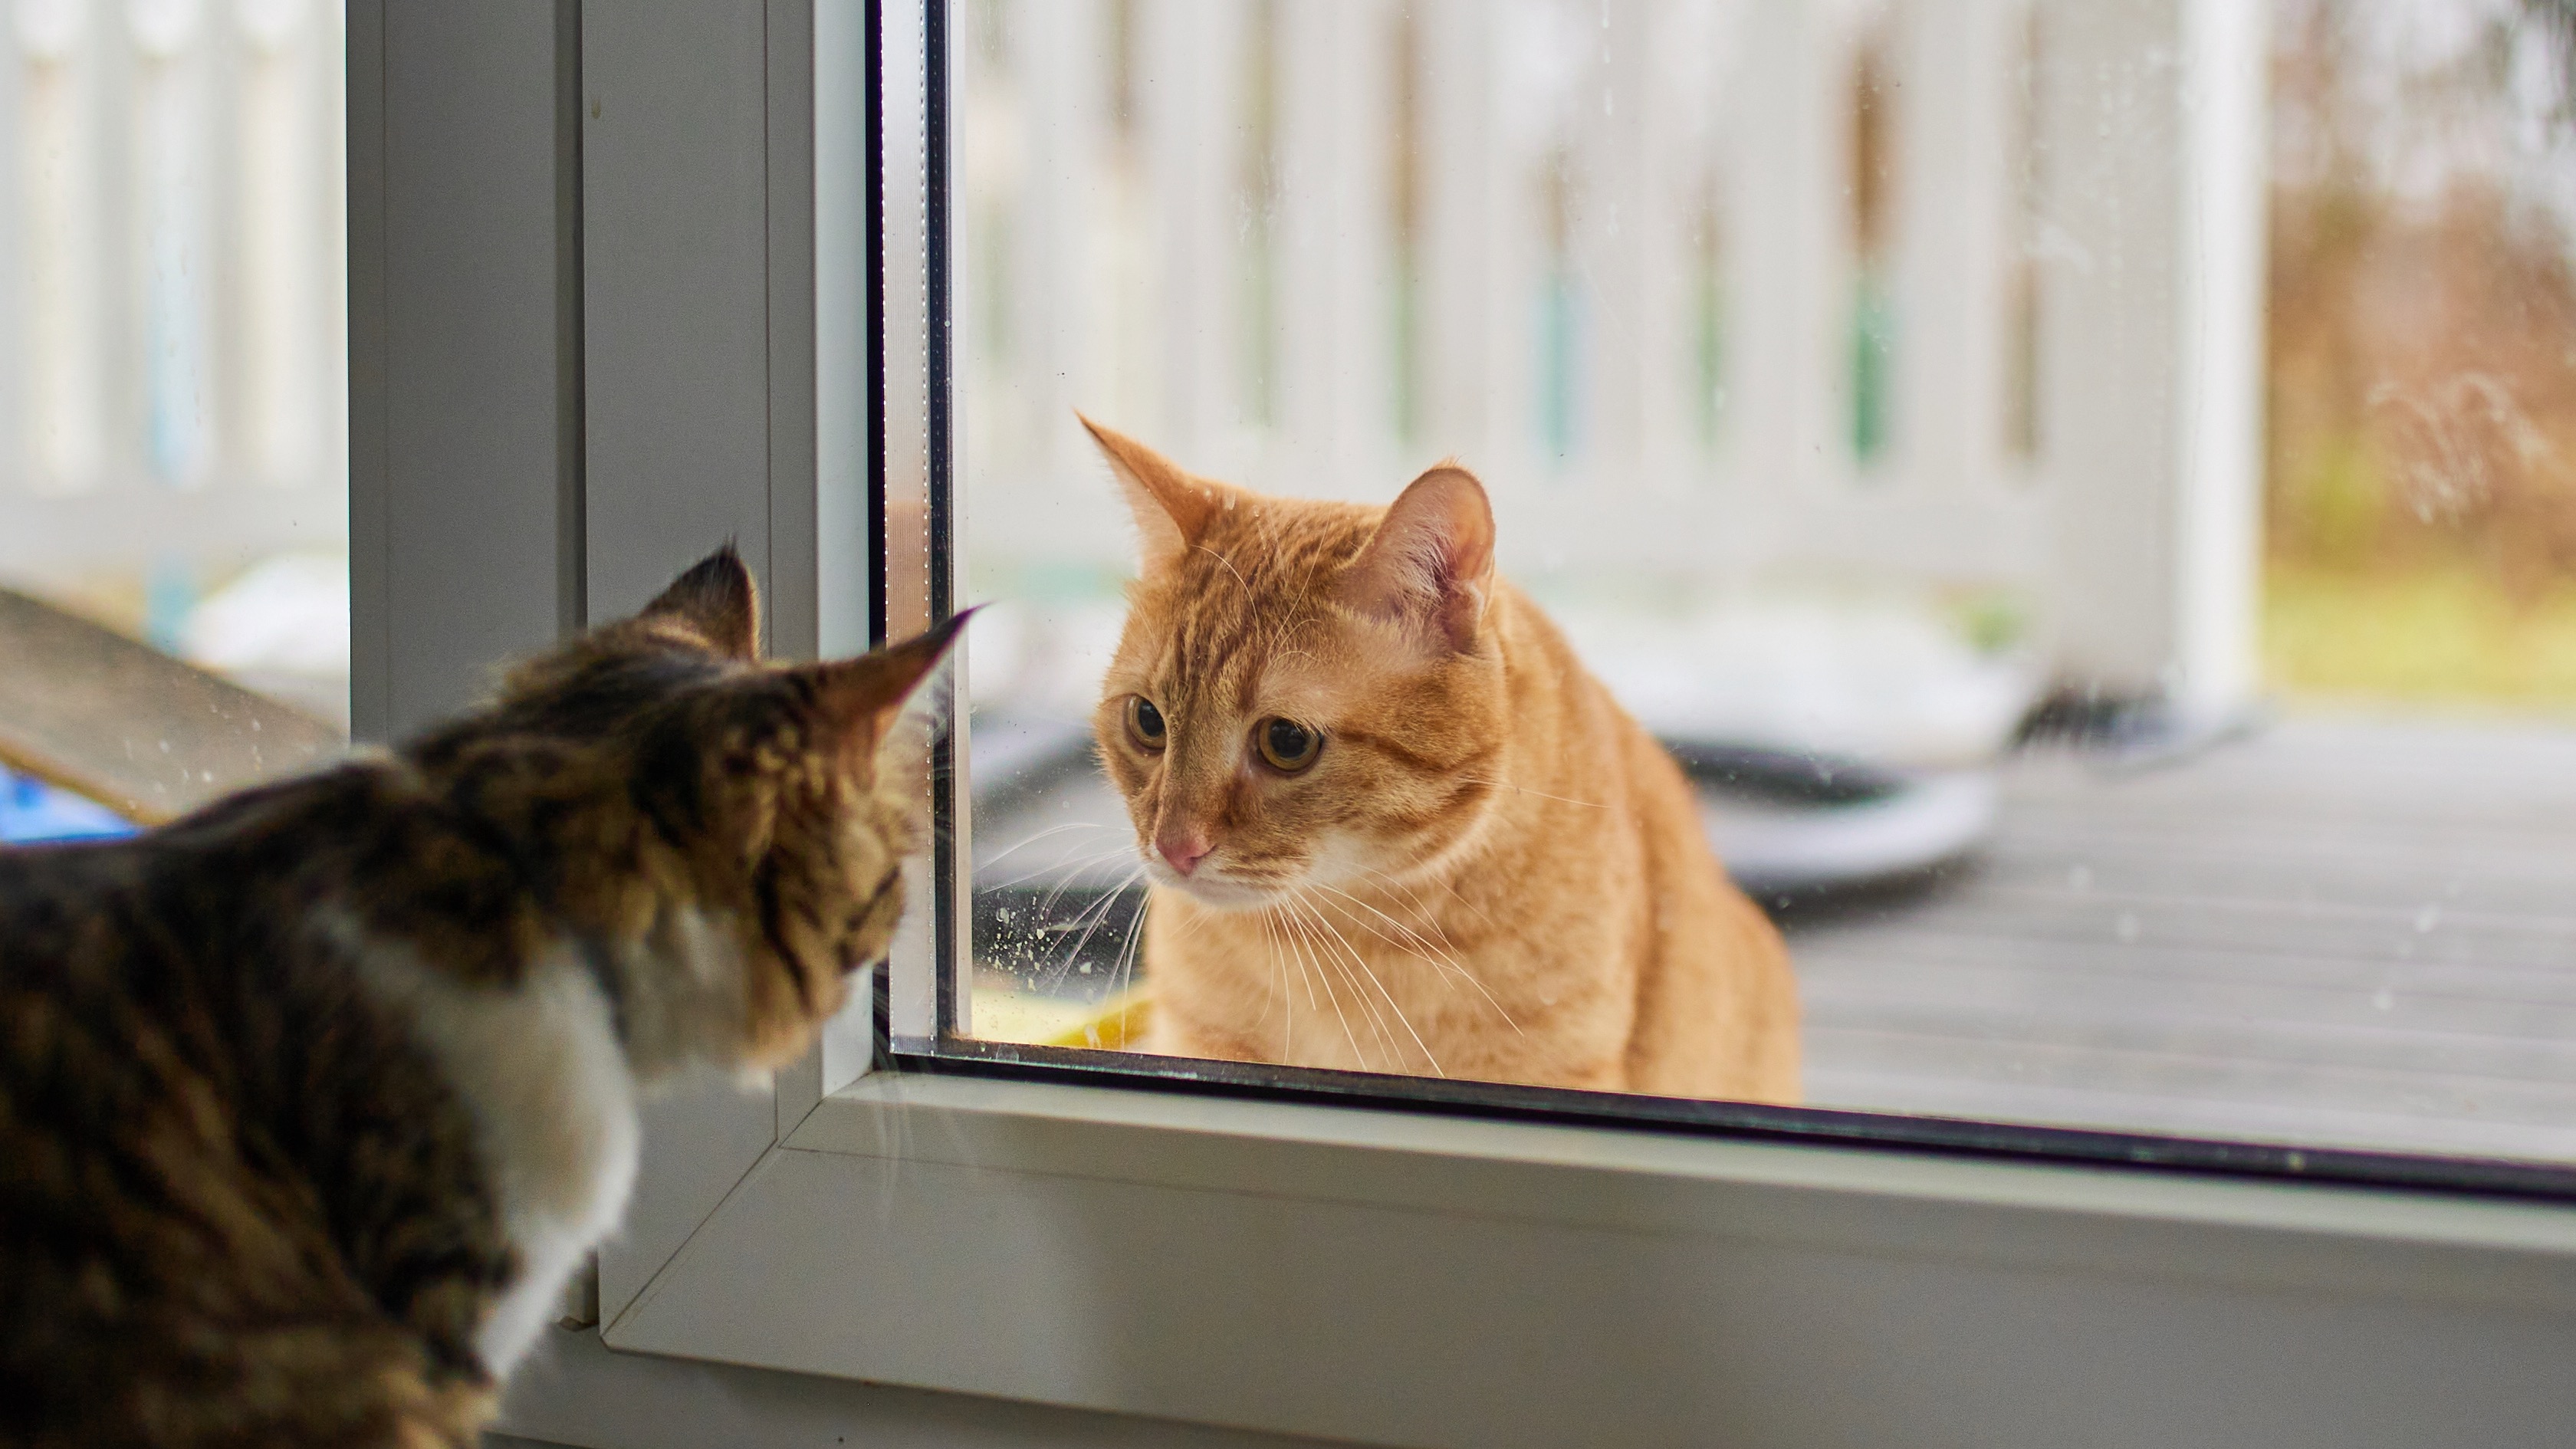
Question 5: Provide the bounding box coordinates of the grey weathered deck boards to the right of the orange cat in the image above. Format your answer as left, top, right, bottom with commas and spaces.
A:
1790, 719, 2576, 1160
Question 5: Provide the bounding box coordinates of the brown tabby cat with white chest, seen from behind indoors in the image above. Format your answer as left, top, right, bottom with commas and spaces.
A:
0, 549, 956, 1447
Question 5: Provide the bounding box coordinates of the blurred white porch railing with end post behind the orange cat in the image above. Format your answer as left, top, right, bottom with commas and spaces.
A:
956, 0, 2264, 704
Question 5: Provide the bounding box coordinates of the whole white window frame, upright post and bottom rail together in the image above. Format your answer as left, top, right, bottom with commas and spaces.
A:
348, 0, 2576, 1449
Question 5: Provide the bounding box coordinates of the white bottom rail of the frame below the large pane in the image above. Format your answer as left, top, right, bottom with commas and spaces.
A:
608, 1078, 2576, 1447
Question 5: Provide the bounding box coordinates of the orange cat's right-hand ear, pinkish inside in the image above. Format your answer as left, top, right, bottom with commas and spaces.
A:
1334, 464, 1494, 655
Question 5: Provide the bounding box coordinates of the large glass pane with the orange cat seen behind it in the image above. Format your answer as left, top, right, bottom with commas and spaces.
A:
948, 0, 2576, 1160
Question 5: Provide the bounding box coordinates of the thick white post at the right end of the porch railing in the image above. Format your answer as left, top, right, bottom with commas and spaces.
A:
2040, 0, 2264, 715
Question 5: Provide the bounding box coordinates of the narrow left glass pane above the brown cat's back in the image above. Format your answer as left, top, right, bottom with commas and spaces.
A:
0, 0, 348, 840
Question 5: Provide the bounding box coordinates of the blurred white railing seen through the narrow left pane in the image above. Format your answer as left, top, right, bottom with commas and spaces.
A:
0, 0, 348, 593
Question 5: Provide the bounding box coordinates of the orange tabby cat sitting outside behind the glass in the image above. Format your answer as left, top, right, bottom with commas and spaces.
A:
1085, 420, 1798, 1101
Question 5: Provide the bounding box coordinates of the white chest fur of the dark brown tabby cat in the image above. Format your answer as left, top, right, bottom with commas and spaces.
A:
360, 922, 642, 1377
